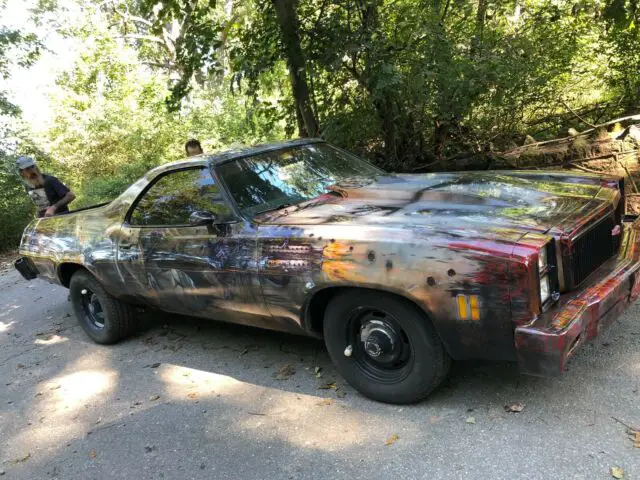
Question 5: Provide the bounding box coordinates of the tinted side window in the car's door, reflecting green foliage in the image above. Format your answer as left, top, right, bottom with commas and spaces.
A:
130, 168, 232, 225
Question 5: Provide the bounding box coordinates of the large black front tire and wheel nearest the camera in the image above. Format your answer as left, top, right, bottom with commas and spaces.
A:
324, 290, 451, 404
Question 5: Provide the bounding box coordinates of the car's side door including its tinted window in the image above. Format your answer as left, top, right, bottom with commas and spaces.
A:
128, 167, 262, 324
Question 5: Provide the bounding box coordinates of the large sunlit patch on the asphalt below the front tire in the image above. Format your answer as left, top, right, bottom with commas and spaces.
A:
157, 364, 404, 452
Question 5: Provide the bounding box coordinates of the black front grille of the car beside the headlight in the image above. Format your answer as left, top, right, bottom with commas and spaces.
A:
571, 216, 615, 287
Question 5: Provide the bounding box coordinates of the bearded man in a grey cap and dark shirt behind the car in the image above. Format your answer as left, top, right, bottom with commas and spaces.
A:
16, 157, 76, 217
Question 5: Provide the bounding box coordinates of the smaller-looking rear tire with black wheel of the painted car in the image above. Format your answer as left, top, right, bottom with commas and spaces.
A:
69, 270, 136, 345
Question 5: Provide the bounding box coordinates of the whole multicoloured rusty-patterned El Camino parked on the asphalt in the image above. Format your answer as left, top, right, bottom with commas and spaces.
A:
16, 139, 640, 403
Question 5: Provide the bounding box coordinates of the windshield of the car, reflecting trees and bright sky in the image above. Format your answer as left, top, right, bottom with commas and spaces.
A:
217, 143, 384, 217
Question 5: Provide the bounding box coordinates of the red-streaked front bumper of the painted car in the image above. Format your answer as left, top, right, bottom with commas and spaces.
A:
515, 218, 640, 376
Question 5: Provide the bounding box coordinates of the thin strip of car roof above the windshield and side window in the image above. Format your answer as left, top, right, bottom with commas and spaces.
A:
147, 138, 324, 178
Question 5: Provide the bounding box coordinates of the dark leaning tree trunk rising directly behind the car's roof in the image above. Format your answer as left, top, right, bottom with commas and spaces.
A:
273, 0, 319, 137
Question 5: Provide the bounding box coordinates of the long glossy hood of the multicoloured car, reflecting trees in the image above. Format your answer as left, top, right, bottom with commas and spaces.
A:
257, 171, 611, 242
